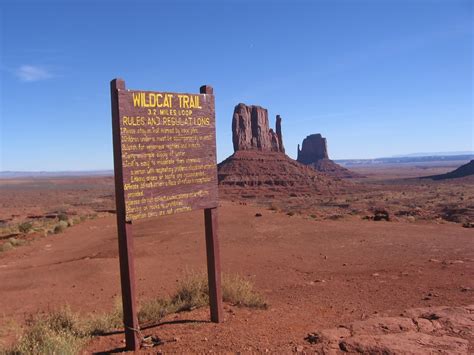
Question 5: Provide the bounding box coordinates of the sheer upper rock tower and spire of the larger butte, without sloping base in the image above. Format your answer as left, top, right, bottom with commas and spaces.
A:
232, 103, 285, 152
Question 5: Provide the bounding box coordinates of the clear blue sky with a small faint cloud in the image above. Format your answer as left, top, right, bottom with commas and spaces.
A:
0, 0, 474, 170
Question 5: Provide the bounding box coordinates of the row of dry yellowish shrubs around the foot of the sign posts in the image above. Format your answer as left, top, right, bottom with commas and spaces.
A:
0, 273, 267, 355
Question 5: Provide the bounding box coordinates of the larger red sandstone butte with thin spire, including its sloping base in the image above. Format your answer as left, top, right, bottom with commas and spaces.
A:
218, 103, 347, 197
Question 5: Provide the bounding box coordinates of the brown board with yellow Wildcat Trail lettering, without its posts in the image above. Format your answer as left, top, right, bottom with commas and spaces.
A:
118, 89, 217, 221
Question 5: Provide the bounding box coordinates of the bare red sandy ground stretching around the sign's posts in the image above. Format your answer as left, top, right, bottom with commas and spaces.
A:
0, 201, 474, 352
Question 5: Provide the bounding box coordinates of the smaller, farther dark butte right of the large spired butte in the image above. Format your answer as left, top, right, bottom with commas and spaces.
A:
296, 133, 362, 178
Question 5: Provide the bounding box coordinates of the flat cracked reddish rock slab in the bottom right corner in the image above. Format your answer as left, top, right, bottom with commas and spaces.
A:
305, 305, 474, 354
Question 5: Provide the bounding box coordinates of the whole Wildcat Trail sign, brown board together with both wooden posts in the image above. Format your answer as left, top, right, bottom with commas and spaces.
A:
110, 79, 223, 350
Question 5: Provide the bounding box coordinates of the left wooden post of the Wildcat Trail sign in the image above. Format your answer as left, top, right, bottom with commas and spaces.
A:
110, 79, 140, 351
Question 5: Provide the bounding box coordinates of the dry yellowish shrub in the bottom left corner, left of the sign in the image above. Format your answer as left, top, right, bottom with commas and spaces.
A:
4, 308, 88, 355
